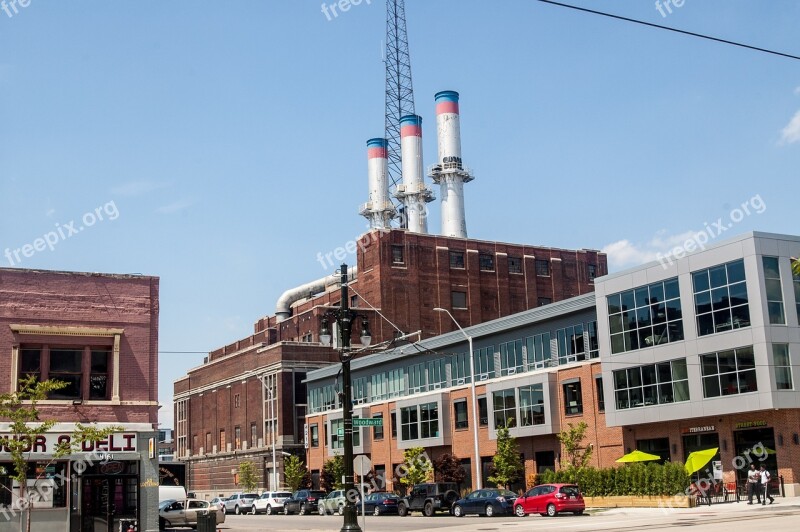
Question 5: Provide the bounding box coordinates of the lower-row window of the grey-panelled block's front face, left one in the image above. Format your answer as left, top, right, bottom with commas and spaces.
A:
614, 358, 689, 410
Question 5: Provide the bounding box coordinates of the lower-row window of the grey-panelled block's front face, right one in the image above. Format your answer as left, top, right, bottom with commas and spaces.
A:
700, 346, 758, 398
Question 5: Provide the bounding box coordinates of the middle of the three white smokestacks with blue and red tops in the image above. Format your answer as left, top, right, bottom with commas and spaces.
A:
395, 115, 434, 234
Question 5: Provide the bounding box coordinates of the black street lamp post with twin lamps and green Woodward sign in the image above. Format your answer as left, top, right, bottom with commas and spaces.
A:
319, 264, 372, 532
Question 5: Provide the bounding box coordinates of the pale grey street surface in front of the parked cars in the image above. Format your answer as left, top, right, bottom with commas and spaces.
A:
176, 498, 800, 532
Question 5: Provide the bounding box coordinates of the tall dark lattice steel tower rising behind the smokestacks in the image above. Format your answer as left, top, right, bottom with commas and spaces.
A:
385, 0, 416, 226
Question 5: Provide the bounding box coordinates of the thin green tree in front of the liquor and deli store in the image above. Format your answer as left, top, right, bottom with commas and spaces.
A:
0, 375, 123, 532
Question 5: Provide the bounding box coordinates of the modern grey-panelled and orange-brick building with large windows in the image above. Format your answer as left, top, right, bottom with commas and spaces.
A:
306, 233, 800, 495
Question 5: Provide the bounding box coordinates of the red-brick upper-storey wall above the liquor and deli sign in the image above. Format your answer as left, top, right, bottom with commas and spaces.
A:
0, 269, 159, 424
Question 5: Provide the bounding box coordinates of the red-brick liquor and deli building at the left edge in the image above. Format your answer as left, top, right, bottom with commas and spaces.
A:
0, 268, 159, 531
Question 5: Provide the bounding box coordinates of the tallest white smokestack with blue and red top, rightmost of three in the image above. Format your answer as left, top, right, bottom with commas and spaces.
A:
431, 91, 474, 238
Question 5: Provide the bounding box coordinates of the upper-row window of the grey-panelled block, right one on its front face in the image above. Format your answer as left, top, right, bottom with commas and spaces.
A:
692, 259, 750, 336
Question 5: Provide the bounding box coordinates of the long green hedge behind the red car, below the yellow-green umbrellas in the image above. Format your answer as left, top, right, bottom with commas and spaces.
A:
536, 462, 691, 497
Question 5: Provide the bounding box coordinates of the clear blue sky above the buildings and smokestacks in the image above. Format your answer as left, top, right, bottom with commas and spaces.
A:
0, 0, 800, 425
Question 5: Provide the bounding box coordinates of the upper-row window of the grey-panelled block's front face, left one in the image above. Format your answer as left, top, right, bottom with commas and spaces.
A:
607, 277, 683, 354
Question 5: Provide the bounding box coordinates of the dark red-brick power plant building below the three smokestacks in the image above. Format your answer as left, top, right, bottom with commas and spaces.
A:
174, 230, 607, 498
